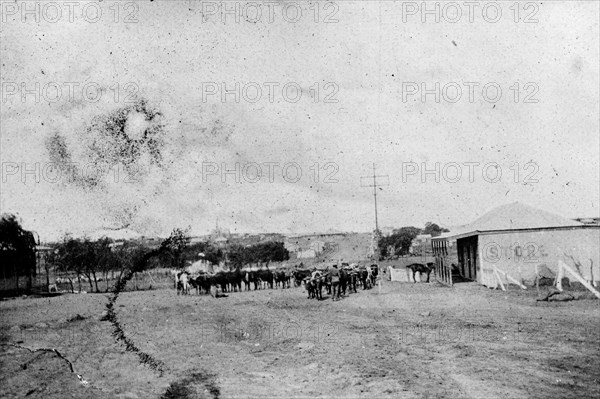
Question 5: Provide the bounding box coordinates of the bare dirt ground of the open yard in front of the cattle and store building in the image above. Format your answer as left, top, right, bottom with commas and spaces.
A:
0, 281, 600, 399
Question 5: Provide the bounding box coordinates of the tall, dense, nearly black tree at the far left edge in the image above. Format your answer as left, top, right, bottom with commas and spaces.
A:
0, 214, 36, 290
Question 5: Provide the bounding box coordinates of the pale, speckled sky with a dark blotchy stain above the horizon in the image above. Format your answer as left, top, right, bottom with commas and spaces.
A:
0, 0, 600, 240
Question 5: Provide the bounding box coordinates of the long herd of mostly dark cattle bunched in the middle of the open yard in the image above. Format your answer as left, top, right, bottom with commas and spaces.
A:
171, 263, 392, 299
